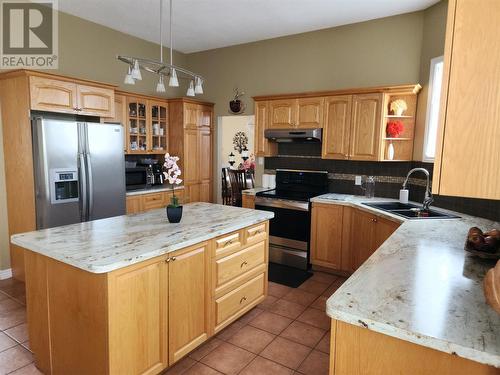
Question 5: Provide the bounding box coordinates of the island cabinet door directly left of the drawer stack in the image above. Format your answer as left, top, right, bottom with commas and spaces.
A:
168, 244, 208, 364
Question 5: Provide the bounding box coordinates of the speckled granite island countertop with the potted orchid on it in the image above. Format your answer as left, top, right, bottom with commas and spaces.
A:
11, 203, 274, 273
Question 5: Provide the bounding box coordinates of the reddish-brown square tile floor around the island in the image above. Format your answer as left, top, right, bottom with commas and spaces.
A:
0, 272, 345, 375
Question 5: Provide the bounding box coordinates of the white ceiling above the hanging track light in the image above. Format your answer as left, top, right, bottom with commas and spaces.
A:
59, 0, 439, 53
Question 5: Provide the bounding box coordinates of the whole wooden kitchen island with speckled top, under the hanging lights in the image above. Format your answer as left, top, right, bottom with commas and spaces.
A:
11, 203, 273, 375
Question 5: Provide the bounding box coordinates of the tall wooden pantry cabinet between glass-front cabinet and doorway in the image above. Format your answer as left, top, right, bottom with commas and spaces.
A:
169, 99, 213, 202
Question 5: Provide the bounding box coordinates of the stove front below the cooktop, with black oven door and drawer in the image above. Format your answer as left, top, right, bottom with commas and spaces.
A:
255, 197, 311, 270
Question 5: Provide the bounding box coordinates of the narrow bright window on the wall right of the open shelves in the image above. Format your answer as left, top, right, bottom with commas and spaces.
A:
423, 56, 443, 161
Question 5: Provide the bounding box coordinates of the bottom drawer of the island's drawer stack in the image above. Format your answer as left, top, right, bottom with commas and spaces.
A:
215, 273, 265, 325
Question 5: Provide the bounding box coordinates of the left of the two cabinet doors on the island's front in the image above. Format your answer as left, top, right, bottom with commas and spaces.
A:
109, 258, 167, 374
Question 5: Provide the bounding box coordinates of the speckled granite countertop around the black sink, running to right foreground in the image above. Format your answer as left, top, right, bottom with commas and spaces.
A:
313, 194, 500, 367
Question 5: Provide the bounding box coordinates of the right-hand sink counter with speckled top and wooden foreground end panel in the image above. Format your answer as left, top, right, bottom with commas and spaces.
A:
312, 194, 500, 374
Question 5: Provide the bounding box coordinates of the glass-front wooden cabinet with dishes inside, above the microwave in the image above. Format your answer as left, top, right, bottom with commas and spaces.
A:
125, 97, 168, 154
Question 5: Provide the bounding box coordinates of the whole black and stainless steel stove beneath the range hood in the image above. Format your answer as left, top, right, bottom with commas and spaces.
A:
255, 169, 328, 270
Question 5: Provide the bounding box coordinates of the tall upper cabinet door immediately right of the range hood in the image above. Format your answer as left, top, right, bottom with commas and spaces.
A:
322, 95, 352, 160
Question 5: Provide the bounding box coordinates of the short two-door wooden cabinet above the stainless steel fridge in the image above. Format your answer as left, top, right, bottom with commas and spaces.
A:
29, 75, 115, 117
